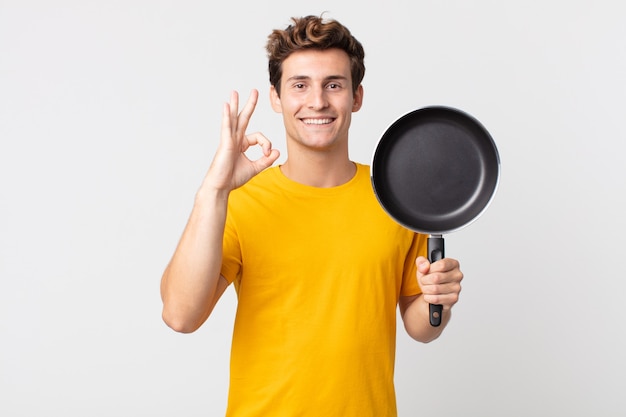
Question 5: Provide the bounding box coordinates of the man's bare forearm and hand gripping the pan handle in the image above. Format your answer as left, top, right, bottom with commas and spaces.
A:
398, 257, 463, 343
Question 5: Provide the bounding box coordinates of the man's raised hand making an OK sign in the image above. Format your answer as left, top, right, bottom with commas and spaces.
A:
203, 90, 280, 193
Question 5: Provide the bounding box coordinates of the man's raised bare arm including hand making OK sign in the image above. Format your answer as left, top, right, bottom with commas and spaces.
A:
161, 90, 279, 333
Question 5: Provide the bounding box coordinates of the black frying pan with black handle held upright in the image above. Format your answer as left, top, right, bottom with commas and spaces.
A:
371, 106, 500, 326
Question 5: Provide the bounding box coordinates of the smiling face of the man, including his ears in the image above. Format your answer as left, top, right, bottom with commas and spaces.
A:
270, 49, 363, 150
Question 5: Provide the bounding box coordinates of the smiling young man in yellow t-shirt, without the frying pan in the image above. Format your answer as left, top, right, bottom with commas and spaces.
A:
161, 16, 463, 417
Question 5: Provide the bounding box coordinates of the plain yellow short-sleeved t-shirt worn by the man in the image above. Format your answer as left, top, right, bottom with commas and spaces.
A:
222, 164, 426, 417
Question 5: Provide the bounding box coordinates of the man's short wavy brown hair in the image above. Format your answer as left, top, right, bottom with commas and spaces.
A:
266, 16, 365, 96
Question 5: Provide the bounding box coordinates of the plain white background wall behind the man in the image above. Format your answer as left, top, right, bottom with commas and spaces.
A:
0, 0, 626, 417
